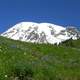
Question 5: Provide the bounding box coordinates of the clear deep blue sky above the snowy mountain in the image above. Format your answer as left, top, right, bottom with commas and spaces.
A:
0, 0, 80, 33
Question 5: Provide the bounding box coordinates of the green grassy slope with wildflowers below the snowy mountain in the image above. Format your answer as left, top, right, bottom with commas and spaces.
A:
0, 37, 80, 80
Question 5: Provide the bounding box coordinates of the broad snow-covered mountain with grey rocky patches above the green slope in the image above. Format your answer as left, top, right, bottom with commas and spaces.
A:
1, 22, 78, 45
